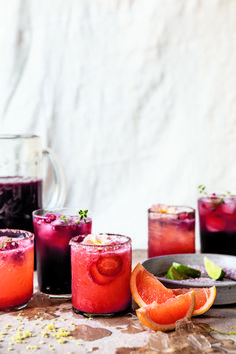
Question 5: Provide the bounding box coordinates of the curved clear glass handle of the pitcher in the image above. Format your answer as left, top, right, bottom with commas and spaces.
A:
43, 147, 66, 209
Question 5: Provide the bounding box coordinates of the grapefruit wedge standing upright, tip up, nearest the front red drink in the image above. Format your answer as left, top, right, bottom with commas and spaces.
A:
130, 263, 175, 307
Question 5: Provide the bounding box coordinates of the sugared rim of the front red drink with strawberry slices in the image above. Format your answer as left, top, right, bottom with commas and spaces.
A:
69, 232, 132, 249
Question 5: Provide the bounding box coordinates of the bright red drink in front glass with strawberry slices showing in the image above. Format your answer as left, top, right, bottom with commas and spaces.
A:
70, 235, 132, 315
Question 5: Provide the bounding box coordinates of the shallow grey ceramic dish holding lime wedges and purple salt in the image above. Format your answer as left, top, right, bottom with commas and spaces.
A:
142, 253, 236, 305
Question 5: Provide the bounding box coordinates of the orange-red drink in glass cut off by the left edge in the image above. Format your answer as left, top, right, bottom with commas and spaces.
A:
0, 230, 34, 310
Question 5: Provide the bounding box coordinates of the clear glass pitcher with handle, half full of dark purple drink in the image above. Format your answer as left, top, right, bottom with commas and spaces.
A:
0, 135, 66, 232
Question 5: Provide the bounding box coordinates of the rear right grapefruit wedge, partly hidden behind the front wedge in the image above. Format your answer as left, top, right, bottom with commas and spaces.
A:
172, 286, 216, 316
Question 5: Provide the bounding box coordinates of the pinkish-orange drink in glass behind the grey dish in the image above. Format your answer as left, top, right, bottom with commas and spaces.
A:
148, 204, 195, 258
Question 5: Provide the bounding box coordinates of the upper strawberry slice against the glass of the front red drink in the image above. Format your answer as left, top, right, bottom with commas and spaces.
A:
97, 255, 123, 276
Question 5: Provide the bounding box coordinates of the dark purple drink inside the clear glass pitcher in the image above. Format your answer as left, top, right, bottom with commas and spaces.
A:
0, 176, 43, 232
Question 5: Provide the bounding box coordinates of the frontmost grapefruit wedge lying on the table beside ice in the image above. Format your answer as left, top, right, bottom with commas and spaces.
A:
136, 291, 195, 331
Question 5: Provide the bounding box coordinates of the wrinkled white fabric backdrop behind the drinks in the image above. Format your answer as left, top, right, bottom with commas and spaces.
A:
0, 0, 236, 248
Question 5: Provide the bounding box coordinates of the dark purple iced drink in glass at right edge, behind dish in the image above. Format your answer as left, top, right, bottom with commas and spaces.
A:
198, 195, 236, 256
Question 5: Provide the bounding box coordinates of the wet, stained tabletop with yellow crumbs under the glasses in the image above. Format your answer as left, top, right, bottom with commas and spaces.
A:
0, 250, 236, 354
